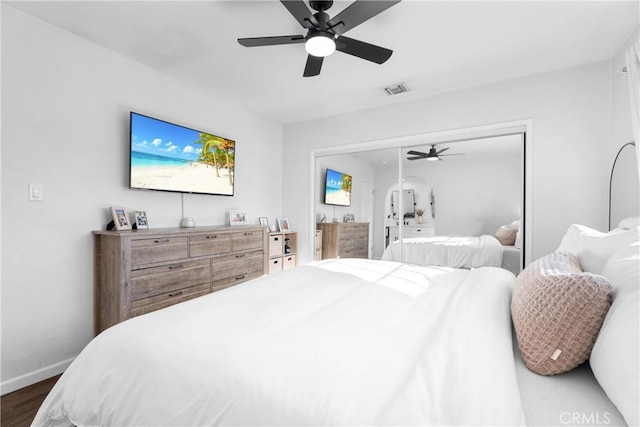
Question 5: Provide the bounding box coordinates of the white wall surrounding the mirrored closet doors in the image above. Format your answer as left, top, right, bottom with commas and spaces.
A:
283, 62, 611, 262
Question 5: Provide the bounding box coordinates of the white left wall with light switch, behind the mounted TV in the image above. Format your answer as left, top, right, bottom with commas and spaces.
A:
1, 4, 283, 394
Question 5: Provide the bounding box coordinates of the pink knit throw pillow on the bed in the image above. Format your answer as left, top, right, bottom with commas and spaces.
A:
511, 252, 612, 375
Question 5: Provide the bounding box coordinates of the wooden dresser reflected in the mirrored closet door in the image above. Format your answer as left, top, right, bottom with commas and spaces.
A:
316, 222, 369, 259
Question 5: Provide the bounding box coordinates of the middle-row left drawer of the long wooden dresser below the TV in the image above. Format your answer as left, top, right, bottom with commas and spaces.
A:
131, 259, 211, 301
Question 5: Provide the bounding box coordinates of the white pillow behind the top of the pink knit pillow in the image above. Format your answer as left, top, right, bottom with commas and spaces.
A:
556, 224, 640, 274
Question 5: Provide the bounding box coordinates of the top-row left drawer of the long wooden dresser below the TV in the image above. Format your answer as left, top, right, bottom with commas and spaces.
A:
131, 236, 189, 267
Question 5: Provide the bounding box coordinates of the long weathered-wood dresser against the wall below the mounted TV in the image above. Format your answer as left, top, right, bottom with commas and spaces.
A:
93, 226, 267, 334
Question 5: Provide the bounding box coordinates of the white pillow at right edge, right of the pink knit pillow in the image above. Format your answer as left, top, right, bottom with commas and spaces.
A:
590, 240, 640, 426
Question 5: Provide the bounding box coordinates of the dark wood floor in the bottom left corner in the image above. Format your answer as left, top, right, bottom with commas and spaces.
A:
0, 375, 60, 427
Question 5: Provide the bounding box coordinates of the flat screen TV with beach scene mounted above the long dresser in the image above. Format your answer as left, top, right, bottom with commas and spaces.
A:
129, 112, 236, 196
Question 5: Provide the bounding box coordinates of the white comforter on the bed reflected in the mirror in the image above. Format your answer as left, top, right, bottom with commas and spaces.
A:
382, 234, 503, 268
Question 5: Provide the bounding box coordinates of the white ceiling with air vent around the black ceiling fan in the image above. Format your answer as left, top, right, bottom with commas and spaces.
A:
3, 0, 640, 124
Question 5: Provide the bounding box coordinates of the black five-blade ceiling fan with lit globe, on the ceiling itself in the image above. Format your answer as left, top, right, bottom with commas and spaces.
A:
238, 0, 400, 77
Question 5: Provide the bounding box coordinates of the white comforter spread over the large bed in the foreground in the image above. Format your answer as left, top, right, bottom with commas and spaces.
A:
34, 259, 524, 426
